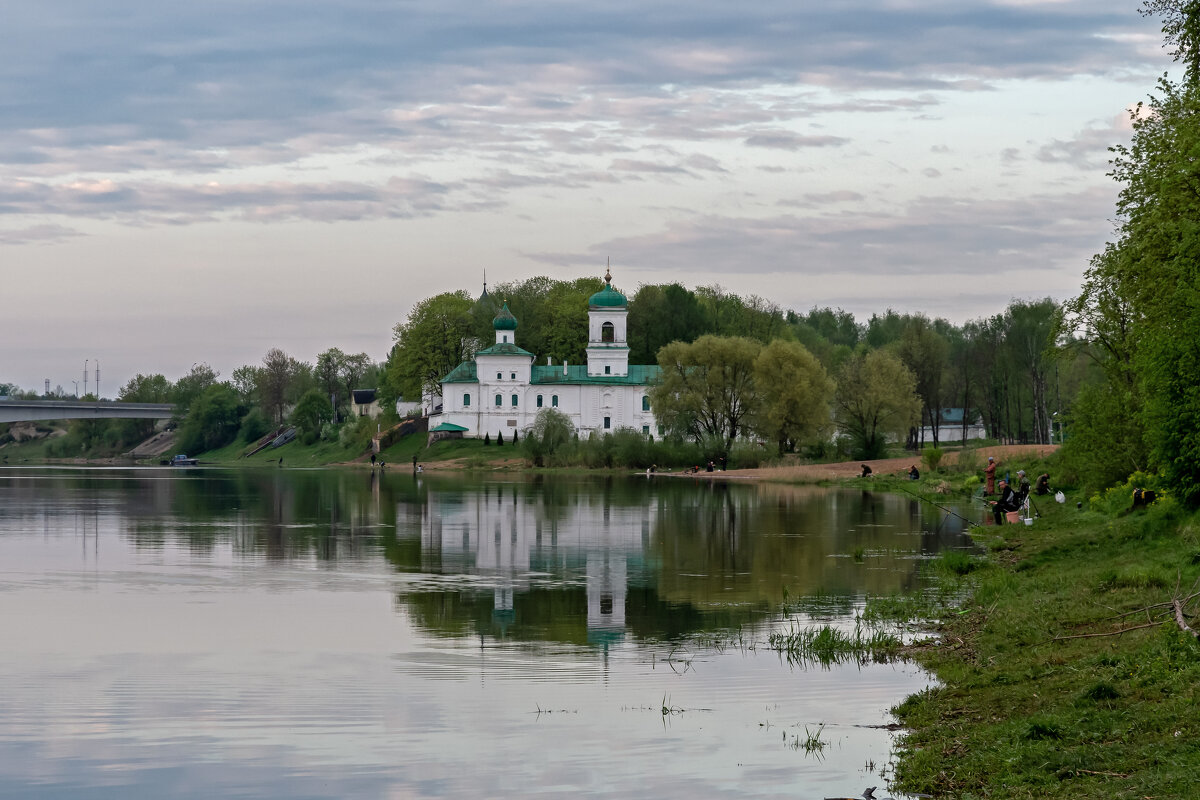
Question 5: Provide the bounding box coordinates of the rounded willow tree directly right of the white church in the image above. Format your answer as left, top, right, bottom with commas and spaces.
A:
650, 336, 762, 453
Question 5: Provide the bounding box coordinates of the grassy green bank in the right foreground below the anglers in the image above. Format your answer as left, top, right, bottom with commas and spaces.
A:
894, 491, 1200, 799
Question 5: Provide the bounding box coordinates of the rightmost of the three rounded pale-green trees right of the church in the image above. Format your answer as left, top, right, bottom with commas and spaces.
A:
834, 350, 920, 458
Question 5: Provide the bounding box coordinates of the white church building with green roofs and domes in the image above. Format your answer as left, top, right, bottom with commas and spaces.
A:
430, 273, 662, 439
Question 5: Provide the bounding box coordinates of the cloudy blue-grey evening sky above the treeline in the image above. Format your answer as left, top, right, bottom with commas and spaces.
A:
0, 0, 1172, 397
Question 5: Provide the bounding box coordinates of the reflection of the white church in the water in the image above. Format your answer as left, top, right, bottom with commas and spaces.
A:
421, 485, 656, 644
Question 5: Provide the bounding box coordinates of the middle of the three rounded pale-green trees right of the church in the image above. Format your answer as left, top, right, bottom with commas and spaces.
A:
754, 339, 834, 453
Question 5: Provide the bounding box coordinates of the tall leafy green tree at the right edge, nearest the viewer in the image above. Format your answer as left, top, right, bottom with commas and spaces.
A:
1069, 0, 1200, 507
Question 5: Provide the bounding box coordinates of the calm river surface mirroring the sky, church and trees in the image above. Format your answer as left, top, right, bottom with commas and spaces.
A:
0, 468, 970, 800
